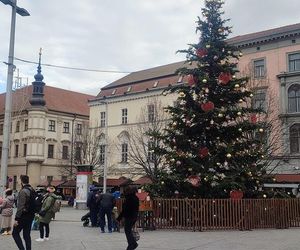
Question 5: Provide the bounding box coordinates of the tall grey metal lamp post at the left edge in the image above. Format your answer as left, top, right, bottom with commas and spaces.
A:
0, 0, 30, 196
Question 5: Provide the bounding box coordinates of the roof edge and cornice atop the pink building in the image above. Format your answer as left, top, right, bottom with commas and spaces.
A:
227, 23, 300, 47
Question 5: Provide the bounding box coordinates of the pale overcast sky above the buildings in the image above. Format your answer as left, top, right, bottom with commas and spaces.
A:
0, 0, 300, 95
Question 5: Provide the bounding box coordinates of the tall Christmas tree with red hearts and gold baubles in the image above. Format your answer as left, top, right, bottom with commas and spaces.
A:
149, 0, 266, 198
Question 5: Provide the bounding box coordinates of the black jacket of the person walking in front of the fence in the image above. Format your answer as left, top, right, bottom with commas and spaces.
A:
117, 194, 139, 220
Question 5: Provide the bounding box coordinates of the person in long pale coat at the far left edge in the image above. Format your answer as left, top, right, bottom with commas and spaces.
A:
0, 189, 14, 235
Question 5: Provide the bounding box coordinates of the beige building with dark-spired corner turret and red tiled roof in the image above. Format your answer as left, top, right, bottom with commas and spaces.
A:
0, 57, 94, 189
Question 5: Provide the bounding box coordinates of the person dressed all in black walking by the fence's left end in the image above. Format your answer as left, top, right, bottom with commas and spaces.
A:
117, 186, 139, 250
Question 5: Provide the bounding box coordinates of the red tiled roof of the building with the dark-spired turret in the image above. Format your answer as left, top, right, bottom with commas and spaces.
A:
0, 85, 95, 116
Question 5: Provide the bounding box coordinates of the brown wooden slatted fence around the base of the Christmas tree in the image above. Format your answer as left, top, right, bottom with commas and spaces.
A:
118, 199, 300, 231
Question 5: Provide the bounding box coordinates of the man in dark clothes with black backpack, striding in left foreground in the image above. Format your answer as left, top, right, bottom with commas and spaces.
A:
12, 175, 35, 250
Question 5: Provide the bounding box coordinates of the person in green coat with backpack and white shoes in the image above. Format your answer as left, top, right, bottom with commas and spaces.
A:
35, 187, 61, 242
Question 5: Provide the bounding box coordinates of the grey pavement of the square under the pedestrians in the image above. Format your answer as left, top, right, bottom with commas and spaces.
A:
0, 208, 300, 250
